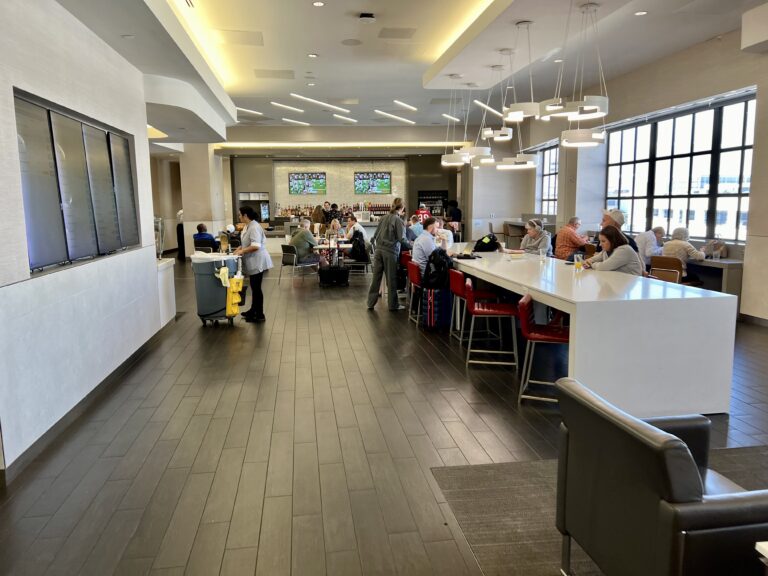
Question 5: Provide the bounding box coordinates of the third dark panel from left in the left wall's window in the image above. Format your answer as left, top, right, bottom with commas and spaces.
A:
83, 124, 122, 254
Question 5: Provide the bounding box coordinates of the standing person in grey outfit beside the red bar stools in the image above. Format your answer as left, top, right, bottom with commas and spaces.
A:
368, 198, 408, 312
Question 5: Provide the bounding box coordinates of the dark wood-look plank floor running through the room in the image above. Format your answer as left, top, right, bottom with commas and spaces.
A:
0, 266, 768, 576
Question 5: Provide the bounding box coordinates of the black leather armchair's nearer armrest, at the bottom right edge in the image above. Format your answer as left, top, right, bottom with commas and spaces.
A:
661, 490, 768, 532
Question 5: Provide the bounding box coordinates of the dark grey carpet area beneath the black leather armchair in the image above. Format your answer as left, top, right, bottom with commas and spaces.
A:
432, 446, 768, 576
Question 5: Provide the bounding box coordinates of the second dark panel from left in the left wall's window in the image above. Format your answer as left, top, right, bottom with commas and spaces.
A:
51, 112, 98, 260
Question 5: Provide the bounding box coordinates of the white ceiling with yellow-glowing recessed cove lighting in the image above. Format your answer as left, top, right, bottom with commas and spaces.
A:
59, 0, 764, 128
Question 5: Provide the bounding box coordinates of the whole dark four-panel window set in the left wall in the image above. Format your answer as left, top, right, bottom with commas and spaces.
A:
15, 96, 139, 270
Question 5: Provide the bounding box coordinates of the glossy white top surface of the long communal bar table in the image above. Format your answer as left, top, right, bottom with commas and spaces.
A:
455, 252, 734, 303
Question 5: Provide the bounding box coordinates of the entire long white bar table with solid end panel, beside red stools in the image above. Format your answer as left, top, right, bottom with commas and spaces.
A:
455, 252, 737, 417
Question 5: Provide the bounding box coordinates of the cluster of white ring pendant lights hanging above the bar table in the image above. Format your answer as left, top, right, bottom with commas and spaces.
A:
442, 0, 609, 170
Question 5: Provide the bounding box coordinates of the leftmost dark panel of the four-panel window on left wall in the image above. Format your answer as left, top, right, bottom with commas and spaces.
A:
15, 98, 67, 270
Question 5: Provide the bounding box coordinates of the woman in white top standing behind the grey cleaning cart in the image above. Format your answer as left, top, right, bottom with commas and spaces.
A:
235, 206, 272, 322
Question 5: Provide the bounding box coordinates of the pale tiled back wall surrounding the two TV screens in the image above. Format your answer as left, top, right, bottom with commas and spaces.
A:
272, 160, 407, 206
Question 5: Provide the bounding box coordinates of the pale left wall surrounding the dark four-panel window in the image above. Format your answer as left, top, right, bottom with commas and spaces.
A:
0, 0, 160, 464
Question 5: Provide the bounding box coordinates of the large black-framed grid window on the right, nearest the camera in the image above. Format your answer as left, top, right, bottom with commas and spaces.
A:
606, 99, 755, 241
